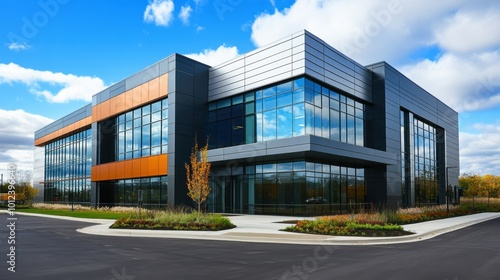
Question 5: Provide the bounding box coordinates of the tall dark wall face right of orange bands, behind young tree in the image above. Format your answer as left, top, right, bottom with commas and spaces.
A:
165, 55, 209, 206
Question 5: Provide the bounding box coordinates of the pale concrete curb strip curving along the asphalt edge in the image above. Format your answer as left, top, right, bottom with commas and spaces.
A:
0, 210, 500, 245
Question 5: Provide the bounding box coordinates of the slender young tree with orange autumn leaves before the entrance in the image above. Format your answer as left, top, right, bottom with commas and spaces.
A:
184, 141, 211, 221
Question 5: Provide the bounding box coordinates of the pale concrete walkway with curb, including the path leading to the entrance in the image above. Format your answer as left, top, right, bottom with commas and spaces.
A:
4, 211, 500, 245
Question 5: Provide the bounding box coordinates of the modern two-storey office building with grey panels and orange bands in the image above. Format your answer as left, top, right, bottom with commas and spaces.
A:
34, 31, 459, 215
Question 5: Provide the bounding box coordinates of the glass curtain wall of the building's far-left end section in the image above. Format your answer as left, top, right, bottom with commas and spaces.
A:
44, 129, 92, 204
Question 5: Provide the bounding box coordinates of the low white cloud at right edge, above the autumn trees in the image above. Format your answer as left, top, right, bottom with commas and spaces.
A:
460, 120, 500, 175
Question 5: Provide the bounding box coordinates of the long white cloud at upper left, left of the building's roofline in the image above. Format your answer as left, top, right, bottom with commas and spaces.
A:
0, 63, 105, 103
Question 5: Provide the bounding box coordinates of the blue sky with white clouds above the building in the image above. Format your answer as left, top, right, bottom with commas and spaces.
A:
0, 0, 500, 175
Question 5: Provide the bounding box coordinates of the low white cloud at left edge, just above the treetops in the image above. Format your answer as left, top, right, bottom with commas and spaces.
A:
0, 109, 53, 170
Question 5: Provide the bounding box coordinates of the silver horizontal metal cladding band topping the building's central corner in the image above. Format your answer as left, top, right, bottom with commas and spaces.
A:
208, 30, 371, 102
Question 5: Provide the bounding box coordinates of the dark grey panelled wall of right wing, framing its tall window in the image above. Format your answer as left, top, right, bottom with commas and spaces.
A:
367, 62, 459, 208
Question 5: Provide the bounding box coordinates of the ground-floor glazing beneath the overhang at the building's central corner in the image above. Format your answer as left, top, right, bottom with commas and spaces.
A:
207, 160, 367, 215
